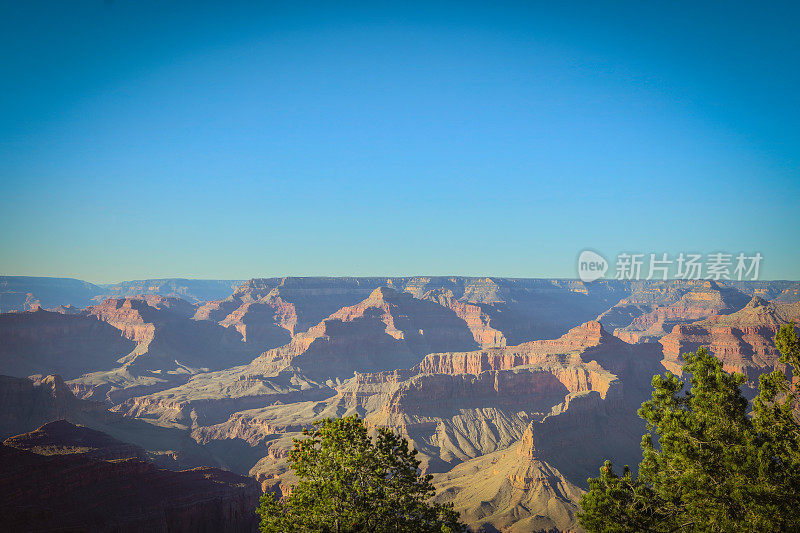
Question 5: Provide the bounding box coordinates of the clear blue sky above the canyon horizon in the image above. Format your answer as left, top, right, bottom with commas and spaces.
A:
0, 0, 800, 282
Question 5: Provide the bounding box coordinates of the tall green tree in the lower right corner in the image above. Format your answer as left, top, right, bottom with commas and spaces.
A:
579, 324, 800, 532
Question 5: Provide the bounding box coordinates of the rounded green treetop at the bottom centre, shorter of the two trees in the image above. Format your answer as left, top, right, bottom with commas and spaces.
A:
256, 416, 466, 533
